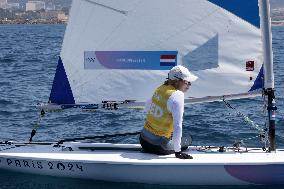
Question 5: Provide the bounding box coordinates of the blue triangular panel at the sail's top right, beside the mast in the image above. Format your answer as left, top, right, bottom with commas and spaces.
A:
208, 0, 260, 28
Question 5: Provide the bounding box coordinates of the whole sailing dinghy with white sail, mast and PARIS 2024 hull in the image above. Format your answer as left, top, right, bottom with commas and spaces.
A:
0, 0, 284, 185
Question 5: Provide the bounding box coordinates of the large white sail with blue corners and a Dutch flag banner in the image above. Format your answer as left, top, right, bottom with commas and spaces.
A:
50, 0, 263, 104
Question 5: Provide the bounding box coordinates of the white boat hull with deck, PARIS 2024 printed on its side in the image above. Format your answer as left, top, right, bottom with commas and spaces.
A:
0, 143, 284, 185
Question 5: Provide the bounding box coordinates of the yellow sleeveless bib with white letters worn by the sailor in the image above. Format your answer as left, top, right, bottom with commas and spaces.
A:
144, 85, 176, 138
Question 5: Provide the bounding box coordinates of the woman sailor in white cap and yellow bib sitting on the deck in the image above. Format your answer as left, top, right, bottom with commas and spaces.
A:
140, 65, 196, 159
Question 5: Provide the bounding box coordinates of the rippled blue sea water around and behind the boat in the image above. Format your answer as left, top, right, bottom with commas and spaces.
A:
0, 25, 284, 189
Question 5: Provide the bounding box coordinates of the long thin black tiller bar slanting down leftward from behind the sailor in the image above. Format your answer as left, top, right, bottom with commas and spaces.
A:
55, 131, 141, 146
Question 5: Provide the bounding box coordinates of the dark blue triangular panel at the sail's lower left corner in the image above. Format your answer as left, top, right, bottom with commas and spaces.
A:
49, 57, 75, 104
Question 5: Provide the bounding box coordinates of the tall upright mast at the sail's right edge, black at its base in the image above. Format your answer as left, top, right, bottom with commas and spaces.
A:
259, 0, 277, 151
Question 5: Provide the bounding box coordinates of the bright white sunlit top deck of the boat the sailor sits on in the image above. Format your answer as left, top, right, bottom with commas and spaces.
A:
0, 142, 284, 165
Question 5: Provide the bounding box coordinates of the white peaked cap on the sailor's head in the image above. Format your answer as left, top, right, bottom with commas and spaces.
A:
168, 65, 197, 82
